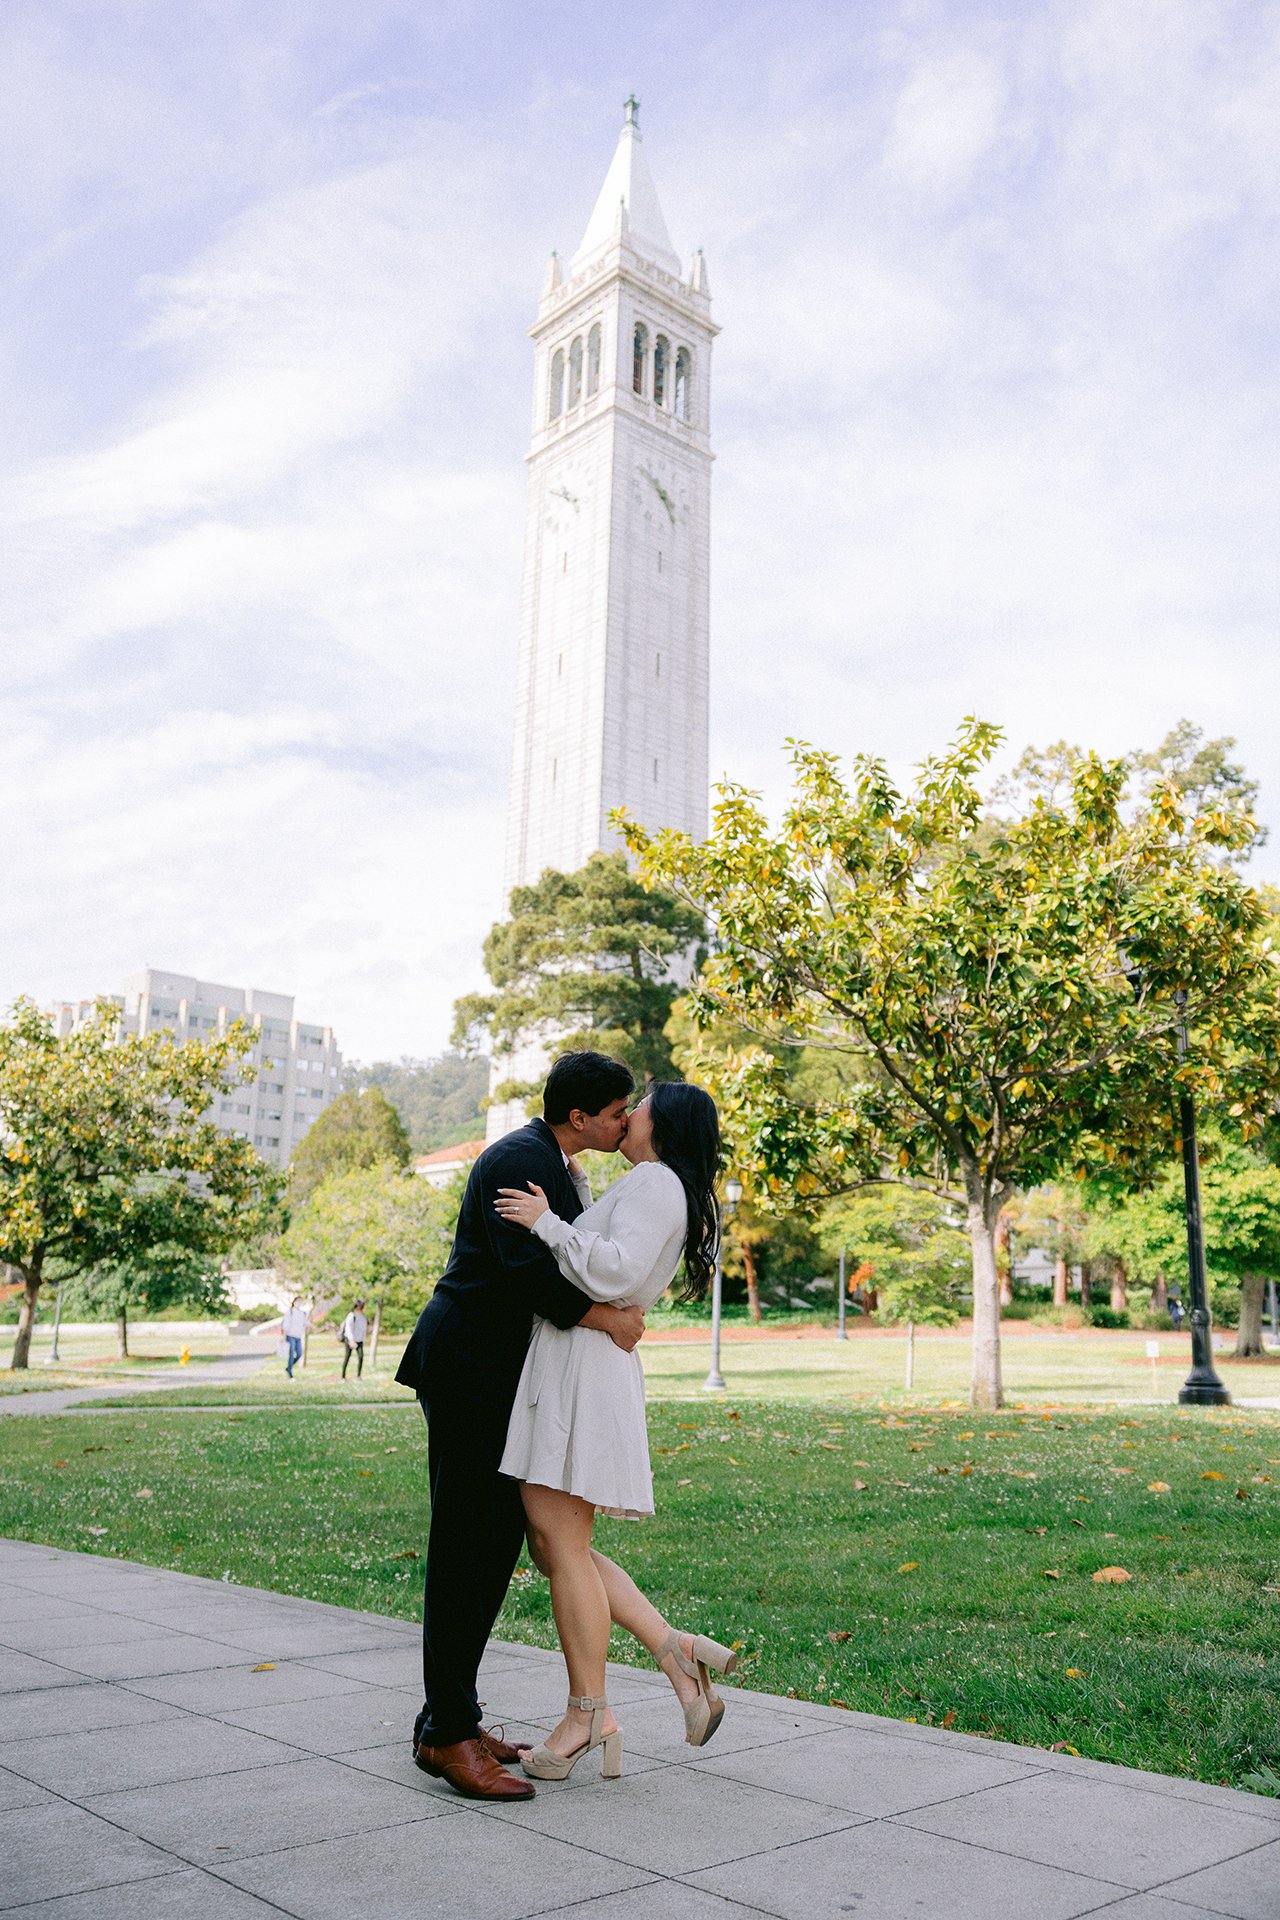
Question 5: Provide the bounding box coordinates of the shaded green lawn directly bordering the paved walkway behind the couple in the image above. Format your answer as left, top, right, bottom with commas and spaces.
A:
0, 1390, 1280, 1782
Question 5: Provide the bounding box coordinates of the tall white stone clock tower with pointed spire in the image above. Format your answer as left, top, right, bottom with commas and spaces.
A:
489, 98, 718, 1139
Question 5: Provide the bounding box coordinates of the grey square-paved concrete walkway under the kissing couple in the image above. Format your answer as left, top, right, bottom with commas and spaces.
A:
0, 1542, 1280, 1920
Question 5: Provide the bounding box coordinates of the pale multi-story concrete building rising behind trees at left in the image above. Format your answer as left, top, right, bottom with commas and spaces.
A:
52, 968, 342, 1167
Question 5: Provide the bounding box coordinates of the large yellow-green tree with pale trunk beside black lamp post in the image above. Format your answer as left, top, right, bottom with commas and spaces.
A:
616, 720, 1280, 1407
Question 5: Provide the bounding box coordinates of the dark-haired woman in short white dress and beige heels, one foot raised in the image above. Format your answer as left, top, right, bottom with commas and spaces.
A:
495, 1081, 737, 1780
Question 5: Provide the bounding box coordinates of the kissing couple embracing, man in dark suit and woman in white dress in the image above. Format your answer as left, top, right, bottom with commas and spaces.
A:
395, 1052, 737, 1801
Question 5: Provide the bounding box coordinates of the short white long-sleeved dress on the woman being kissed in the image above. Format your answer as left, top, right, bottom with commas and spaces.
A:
501, 1160, 687, 1519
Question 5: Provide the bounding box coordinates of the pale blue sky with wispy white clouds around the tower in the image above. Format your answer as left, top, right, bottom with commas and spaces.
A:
0, 0, 1280, 1060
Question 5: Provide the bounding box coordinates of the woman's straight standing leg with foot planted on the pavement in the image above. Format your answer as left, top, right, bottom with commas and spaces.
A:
520, 1482, 618, 1753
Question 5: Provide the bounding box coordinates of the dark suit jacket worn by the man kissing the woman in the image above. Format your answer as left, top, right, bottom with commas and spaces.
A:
395, 1119, 591, 1396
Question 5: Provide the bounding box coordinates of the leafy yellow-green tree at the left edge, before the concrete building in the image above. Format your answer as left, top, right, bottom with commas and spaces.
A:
0, 1000, 278, 1367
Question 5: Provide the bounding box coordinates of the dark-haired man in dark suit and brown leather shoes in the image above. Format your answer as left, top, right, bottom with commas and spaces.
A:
395, 1052, 645, 1799
